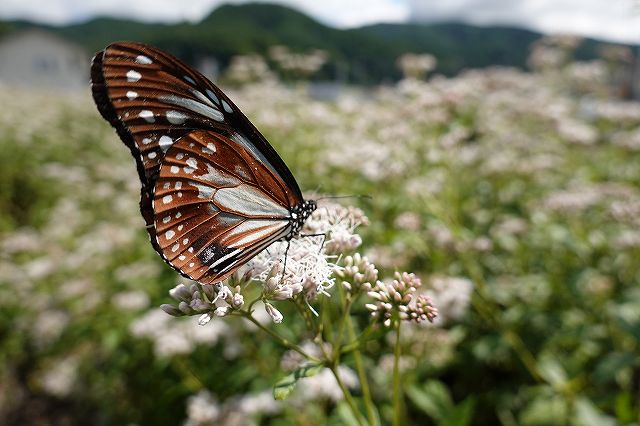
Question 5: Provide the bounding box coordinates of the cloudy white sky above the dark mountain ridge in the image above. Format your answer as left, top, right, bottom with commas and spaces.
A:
0, 0, 640, 44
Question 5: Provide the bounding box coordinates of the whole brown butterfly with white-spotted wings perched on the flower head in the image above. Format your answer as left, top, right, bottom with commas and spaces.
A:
91, 42, 317, 284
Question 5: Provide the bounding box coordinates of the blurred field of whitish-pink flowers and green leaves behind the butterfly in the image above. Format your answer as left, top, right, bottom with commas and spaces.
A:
0, 1, 640, 426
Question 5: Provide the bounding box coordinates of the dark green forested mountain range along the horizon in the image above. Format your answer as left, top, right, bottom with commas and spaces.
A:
0, 3, 632, 84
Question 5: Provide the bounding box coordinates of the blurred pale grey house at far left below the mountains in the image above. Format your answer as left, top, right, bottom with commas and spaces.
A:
0, 29, 91, 89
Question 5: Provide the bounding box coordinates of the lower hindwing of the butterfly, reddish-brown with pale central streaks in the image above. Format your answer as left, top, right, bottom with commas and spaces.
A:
153, 131, 292, 284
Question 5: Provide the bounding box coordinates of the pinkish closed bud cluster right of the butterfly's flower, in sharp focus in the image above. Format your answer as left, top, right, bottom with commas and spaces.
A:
365, 272, 438, 327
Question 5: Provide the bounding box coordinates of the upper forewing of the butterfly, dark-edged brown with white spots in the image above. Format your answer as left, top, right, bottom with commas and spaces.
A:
91, 42, 303, 272
